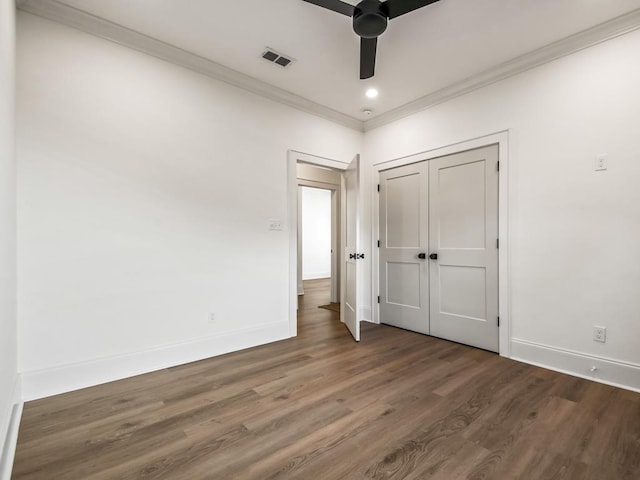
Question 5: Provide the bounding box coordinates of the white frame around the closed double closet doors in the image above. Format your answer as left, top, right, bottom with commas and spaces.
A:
371, 130, 515, 357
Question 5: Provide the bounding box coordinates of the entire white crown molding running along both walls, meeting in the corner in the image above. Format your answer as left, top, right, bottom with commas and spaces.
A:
16, 0, 640, 132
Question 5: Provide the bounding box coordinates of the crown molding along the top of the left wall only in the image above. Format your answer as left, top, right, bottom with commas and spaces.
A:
16, 0, 363, 132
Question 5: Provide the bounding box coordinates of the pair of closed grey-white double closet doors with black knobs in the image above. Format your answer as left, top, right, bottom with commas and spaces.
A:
379, 145, 499, 352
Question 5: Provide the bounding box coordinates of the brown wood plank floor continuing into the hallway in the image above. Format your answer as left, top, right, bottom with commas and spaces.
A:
13, 281, 640, 480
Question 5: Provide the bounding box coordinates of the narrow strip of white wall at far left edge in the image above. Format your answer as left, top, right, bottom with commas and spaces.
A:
0, 0, 18, 464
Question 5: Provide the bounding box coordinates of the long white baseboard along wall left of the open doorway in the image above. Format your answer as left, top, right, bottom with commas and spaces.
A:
21, 322, 289, 401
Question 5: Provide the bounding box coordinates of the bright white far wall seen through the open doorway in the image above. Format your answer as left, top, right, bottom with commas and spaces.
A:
300, 187, 331, 280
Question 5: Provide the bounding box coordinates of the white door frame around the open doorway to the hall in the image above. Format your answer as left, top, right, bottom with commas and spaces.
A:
287, 150, 349, 337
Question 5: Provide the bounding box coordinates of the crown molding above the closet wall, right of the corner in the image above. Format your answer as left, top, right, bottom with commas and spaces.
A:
364, 8, 640, 132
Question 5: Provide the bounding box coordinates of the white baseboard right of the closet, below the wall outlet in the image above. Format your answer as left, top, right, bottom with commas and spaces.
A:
511, 338, 640, 392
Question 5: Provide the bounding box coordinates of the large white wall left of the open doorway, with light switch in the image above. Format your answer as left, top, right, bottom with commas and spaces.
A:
17, 13, 362, 398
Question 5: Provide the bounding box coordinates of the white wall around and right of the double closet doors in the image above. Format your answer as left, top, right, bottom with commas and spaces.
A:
364, 31, 640, 388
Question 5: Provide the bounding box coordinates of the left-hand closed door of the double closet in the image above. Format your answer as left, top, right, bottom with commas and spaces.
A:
379, 162, 429, 334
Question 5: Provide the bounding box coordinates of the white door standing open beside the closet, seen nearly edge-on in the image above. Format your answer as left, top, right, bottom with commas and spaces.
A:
340, 155, 364, 342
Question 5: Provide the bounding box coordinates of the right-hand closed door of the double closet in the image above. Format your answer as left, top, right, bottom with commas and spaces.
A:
429, 145, 498, 352
